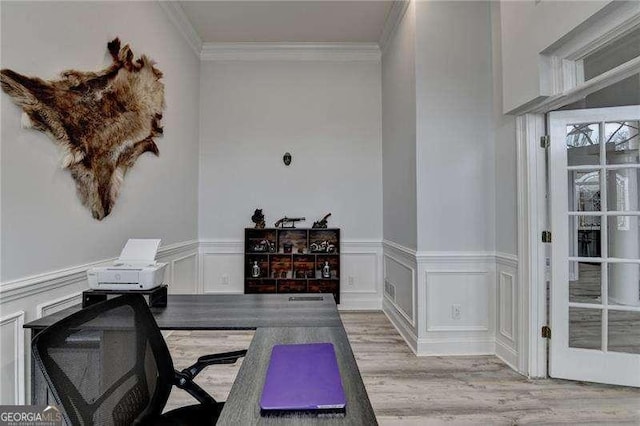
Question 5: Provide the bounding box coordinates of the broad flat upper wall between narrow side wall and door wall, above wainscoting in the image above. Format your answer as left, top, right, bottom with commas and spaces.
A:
416, 1, 495, 252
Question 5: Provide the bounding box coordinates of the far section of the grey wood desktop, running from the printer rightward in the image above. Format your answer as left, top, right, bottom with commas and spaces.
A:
24, 293, 342, 330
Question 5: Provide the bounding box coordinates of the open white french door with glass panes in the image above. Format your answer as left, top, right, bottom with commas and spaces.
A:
548, 105, 640, 386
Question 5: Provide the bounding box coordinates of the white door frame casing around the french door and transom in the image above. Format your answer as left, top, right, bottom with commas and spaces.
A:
510, 2, 640, 377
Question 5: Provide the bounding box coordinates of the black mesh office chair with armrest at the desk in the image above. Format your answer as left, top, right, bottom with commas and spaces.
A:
32, 295, 247, 425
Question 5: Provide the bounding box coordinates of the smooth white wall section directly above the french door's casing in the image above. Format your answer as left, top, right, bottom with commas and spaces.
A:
500, 0, 610, 112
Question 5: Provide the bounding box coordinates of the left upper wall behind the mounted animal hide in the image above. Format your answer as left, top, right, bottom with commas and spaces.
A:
0, 2, 199, 282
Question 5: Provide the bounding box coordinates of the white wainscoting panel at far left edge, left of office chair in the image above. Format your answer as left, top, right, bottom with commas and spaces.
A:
0, 311, 25, 405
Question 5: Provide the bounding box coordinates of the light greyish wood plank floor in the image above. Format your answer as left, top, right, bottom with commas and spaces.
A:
167, 312, 640, 425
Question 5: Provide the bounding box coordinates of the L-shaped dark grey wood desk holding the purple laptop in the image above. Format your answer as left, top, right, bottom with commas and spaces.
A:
24, 294, 377, 425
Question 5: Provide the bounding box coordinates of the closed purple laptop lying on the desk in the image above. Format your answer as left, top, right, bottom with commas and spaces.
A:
260, 343, 347, 413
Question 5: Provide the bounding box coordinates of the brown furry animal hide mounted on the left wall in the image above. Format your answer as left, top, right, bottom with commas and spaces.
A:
0, 38, 165, 220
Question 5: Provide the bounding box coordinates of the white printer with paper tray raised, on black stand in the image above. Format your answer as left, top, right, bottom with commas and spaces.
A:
87, 239, 167, 290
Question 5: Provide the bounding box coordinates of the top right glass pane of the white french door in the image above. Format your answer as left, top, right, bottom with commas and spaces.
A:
604, 121, 640, 164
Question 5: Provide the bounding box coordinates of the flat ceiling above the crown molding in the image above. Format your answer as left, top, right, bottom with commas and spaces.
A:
180, 0, 393, 43
